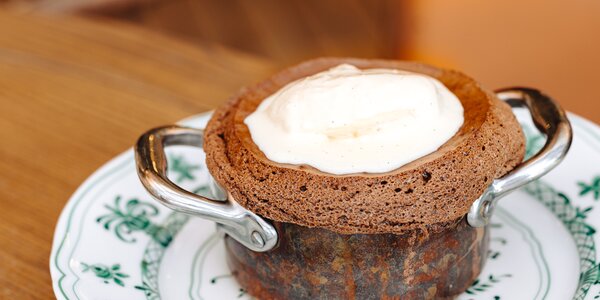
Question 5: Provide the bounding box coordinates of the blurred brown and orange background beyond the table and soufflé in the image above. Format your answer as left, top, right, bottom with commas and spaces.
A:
0, 0, 600, 122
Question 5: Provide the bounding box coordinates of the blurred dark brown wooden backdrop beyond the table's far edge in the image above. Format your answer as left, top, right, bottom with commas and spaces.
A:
0, 0, 408, 64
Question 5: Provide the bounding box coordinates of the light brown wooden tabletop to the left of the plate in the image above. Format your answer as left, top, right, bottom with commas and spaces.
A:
0, 12, 274, 299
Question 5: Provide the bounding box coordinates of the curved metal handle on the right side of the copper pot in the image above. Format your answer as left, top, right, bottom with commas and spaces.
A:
467, 88, 573, 227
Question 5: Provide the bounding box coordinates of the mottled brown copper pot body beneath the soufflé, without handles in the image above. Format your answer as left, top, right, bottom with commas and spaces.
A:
225, 218, 489, 299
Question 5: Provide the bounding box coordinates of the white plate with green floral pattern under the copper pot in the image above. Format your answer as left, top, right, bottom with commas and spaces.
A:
50, 112, 600, 300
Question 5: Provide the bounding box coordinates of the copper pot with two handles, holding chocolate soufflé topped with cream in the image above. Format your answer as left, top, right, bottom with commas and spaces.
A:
135, 58, 571, 299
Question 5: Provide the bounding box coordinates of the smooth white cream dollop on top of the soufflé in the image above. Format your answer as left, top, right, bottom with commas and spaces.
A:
244, 64, 463, 175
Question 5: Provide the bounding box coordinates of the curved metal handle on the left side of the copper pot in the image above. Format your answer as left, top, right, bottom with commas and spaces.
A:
135, 126, 277, 252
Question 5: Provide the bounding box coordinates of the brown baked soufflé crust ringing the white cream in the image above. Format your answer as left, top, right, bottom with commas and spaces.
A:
204, 58, 525, 234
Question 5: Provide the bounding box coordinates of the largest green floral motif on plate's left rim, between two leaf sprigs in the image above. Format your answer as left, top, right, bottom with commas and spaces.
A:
96, 196, 173, 246
